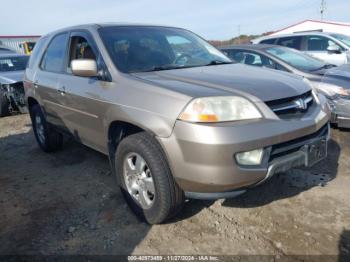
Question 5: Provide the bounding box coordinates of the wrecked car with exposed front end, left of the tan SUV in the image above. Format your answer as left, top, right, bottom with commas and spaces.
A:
0, 52, 28, 117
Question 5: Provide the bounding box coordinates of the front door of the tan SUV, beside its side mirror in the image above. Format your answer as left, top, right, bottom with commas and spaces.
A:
60, 30, 112, 152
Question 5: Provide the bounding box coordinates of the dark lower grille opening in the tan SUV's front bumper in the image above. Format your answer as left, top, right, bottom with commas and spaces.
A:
269, 124, 329, 162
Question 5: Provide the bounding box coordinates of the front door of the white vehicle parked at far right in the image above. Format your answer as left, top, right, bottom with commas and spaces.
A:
305, 35, 347, 65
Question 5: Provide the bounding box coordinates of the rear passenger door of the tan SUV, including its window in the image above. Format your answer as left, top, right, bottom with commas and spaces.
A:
33, 32, 69, 128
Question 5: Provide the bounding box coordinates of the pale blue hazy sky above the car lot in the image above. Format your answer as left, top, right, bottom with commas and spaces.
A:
0, 0, 350, 40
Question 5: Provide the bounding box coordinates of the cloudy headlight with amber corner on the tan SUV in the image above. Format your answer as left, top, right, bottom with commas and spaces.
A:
179, 96, 262, 122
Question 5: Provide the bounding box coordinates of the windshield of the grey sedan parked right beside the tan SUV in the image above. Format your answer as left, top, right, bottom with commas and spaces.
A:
266, 47, 326, 71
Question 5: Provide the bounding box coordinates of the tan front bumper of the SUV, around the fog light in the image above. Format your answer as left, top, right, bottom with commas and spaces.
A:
159, 103, 329, 199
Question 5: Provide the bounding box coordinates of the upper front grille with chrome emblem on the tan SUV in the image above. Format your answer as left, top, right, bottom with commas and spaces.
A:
265, 91, 314, 118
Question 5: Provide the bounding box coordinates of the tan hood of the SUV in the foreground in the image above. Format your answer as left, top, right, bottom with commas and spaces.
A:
133, 64, 310, 101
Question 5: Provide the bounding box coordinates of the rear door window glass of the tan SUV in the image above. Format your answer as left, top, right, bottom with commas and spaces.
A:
41, 33, 68, 72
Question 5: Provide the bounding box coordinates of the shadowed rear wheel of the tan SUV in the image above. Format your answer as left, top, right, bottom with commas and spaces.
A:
30, 105, 63, 152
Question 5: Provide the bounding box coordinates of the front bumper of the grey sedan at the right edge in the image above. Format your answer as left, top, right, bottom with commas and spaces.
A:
328, 98, 350, 128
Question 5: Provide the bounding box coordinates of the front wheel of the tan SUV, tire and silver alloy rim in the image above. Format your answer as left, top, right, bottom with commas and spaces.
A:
115, 132, 184, 224
